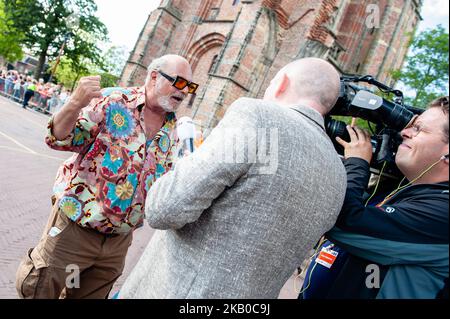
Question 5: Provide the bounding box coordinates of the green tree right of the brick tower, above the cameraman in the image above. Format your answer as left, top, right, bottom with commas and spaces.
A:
392, 25, 449, 107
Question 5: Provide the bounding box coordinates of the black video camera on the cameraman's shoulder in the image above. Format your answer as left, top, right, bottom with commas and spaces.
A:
325, 75, 424, 179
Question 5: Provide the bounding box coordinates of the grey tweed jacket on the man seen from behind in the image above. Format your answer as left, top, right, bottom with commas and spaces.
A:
120, 98, 346, 298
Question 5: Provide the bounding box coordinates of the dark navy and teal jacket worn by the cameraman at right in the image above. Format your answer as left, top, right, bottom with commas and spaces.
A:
326, 158, 449, 298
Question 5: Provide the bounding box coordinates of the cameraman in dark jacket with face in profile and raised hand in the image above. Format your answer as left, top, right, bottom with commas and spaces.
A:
299, 96, 449, 299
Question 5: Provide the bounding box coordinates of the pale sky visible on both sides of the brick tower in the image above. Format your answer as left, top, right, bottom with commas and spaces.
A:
95, 0, 449, 51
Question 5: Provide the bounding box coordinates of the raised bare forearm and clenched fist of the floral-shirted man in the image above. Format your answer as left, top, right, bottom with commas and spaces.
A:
53, 75, 102, 140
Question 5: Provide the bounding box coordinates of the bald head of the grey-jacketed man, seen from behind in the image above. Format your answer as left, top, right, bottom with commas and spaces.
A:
268, 58, 340, 115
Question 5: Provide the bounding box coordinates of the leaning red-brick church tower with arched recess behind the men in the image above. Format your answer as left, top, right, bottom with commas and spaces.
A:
120, 0, 422, 129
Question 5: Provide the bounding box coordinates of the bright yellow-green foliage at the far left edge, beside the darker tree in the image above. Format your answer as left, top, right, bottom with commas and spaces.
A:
0, 0, 23, 62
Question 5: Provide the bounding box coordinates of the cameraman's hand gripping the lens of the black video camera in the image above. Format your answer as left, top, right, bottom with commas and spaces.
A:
336, 125, 373, 164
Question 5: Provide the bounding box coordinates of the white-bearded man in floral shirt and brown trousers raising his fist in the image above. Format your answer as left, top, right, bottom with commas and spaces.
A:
16, 55, 198, 299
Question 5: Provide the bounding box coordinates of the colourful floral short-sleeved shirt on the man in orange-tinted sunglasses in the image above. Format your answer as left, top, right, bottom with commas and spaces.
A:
45, 88, 177, 234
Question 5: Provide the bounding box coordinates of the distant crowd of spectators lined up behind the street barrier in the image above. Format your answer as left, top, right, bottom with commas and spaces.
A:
0, 69, 71, 114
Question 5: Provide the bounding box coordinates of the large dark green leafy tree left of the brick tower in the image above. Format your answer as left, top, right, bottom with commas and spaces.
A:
3, 0, 107, 78
